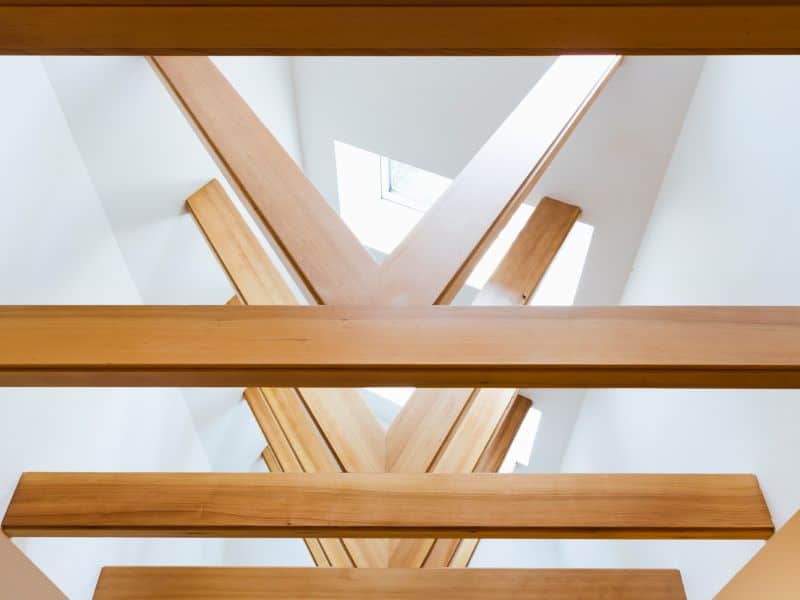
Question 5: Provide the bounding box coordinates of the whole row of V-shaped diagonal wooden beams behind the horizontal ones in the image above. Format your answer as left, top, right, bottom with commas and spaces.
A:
152, 52, 620, 567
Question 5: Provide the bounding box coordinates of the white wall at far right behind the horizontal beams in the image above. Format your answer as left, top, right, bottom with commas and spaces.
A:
562, 57, 800, 599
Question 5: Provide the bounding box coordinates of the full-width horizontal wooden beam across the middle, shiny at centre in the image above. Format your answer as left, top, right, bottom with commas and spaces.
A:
0, 306, 800, 388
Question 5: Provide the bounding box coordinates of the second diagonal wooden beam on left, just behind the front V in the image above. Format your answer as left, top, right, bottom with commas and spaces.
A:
187, 181, 386, 472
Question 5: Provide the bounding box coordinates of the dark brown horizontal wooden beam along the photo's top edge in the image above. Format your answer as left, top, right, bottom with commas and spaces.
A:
0, 0, 800, 56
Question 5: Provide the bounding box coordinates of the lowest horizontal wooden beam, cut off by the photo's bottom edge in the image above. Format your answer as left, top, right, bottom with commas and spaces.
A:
94, 567, 686, 600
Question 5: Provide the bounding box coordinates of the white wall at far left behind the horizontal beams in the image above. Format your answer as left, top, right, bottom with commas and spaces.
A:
0, 57, 221, 599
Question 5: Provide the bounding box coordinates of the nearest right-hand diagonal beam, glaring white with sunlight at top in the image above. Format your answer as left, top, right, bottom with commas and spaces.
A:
373, 56, 621, 306
